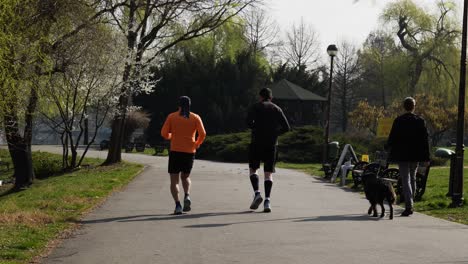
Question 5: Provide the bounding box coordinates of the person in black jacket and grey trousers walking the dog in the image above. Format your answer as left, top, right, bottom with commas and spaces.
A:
386, 97, 429, 216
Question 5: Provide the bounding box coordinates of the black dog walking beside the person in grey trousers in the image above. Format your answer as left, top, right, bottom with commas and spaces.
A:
362, 173, 396, 219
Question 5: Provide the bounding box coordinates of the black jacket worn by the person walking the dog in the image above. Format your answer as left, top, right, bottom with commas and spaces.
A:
386, 113, 430, 162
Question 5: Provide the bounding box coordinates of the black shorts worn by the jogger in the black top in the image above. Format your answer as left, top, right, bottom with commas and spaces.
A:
249, 144, 278, 172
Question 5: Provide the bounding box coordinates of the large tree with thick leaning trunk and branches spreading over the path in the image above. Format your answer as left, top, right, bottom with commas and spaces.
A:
105, 0, 259, 164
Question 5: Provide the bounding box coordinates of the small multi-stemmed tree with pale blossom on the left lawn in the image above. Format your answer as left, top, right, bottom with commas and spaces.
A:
41, 27, 122, 169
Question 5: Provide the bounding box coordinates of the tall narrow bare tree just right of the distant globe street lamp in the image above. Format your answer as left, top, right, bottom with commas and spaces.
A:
332, 41, 361, 132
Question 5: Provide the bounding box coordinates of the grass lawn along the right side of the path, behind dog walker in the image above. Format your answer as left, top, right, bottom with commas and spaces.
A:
278, 163, 468, 225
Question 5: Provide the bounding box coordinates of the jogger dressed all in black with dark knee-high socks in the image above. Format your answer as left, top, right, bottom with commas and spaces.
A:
247, 88, 290, 213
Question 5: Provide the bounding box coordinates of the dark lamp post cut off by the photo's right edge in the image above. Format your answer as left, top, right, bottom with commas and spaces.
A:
451, 0, 468, 207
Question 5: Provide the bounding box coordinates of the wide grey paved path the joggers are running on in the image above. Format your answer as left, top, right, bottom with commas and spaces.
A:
36, 148, 468, 264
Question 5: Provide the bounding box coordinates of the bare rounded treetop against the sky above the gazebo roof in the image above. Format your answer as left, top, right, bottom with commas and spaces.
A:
283, 18, 319, 68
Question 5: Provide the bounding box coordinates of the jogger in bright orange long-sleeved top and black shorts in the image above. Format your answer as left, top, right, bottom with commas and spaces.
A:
161, 96, 206, 214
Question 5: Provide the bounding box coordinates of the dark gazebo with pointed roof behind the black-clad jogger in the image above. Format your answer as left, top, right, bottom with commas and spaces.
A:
271, 79, 327, 126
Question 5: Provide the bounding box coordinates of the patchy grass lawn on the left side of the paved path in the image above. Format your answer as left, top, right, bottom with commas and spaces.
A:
0, 150, 143, 263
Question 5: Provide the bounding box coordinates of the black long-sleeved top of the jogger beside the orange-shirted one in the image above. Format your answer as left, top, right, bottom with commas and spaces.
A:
247, 101, 290, 146
